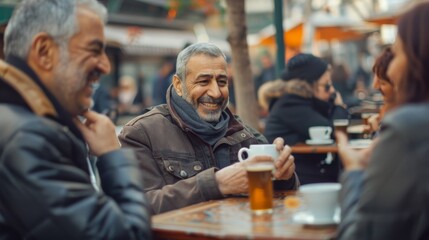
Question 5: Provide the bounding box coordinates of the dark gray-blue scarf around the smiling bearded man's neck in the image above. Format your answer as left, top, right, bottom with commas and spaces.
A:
171, 87, 229, 146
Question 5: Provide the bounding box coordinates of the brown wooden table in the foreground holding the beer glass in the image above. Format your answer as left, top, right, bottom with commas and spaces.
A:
152, 192, 336, 240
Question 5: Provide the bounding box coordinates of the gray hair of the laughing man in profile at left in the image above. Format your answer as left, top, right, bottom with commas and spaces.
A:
4, 0, 107, 59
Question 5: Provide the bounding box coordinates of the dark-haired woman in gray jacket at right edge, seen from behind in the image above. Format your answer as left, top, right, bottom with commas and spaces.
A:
336, 2, 429, 240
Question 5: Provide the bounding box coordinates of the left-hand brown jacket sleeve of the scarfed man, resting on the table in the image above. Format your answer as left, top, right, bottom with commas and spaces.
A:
119, 122, 223, 214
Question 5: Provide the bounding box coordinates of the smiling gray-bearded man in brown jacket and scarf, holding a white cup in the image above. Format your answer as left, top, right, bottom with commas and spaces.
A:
119, 43, 299, 214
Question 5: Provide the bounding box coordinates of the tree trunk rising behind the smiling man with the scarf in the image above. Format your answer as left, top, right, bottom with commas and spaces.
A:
226, 0, 259, 129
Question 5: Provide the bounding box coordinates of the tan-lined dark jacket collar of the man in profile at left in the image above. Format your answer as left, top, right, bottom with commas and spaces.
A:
0, 56, 83, 141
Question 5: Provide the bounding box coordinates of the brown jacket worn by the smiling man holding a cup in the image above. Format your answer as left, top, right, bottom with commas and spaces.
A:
119, 86, 298, 214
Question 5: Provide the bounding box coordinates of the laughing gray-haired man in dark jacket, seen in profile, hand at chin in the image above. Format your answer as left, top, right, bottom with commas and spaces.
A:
0, 0, 151, 239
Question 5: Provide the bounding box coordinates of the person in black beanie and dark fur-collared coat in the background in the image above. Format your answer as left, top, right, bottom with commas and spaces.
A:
264, 53, 349, 184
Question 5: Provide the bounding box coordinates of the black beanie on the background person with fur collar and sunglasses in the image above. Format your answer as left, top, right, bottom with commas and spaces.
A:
281, 53, 328, 84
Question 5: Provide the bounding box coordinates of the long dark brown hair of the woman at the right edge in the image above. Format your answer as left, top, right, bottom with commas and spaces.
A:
398, 2, 429, 103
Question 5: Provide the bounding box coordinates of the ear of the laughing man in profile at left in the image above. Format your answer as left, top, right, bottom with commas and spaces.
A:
28, 33, 59, 70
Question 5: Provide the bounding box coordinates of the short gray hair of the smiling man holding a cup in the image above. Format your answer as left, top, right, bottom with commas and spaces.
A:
176, 42, 226, 82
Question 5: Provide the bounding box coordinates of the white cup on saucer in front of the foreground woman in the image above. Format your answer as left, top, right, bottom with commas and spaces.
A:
298, 183, 341, 220
